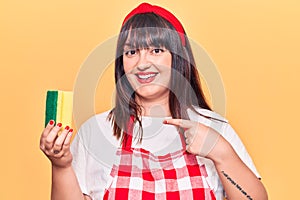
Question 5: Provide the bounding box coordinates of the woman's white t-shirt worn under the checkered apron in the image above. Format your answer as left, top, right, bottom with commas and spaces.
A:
71, 108, 260, 200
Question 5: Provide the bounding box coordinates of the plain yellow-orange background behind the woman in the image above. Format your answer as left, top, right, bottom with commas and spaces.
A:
0, 0, 300, 200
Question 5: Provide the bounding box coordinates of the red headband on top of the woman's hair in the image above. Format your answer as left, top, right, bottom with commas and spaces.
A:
122, 3, 185, 46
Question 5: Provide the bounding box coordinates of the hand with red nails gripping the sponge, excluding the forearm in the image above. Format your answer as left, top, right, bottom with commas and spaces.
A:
40, 120, 73, 168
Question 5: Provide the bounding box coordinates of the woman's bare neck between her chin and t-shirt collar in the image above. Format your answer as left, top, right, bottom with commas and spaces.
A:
136, 94, 171, 117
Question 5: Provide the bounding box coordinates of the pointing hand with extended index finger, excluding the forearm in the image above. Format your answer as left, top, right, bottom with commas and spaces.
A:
164, 119, 223, 157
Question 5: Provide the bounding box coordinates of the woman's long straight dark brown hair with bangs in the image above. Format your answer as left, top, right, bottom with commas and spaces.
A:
108, 13, 211, 142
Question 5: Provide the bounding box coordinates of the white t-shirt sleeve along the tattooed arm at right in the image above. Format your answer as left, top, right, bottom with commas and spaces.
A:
222, 123, 261, 178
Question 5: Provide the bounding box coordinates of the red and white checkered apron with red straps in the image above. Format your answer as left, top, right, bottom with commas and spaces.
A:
103, 117, 216, 200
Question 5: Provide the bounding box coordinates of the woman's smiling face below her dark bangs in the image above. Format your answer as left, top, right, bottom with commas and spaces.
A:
123, 44, 172, 100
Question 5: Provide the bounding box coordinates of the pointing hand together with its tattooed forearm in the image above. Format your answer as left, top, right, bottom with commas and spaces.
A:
164, 119, 268, 200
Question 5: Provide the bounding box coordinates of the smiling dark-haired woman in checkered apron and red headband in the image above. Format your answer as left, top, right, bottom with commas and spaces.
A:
41, 3, 267, 200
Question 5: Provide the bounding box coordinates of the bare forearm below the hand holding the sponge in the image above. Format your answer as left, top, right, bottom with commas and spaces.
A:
51, 166, 85, 200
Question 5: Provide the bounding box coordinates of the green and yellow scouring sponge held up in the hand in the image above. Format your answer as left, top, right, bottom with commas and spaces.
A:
45, 90, 73, 126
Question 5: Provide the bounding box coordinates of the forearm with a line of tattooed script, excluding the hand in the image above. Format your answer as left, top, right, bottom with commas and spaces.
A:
214, 141, 268, 200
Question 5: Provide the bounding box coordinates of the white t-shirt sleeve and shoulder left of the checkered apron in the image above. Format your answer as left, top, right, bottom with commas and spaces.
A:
71, 113, 118, 200
